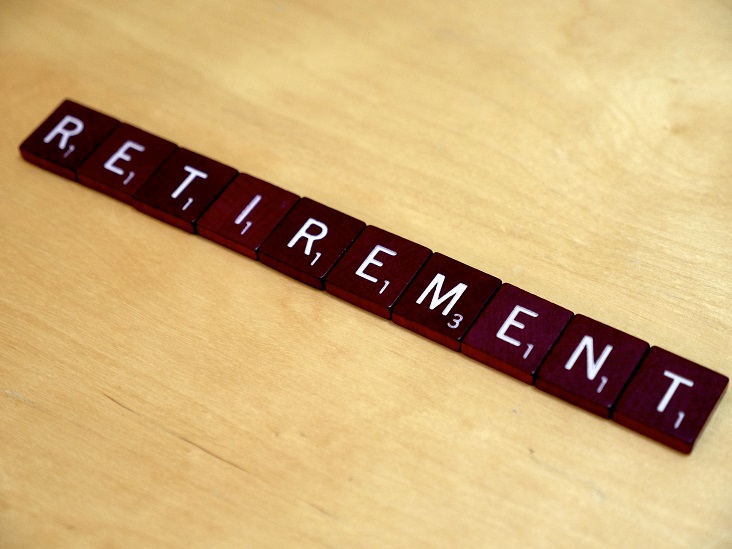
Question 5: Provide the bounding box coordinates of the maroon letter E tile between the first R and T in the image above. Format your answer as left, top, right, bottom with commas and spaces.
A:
76, 124, 176, 202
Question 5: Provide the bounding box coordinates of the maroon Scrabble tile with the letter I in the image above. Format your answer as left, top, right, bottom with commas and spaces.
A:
196, 173, 299, 259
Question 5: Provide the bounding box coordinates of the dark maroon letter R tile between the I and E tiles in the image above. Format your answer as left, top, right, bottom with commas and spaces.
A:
259, 198, 365, 290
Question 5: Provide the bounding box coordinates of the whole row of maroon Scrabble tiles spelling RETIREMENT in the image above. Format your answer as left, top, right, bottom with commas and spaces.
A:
20, 100, 729, 453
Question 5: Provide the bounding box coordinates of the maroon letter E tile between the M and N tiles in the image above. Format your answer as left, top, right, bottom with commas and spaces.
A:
461, 284, 572, 383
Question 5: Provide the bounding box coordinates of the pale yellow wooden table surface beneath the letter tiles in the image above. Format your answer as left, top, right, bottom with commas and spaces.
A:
0, 0, 732, 548
